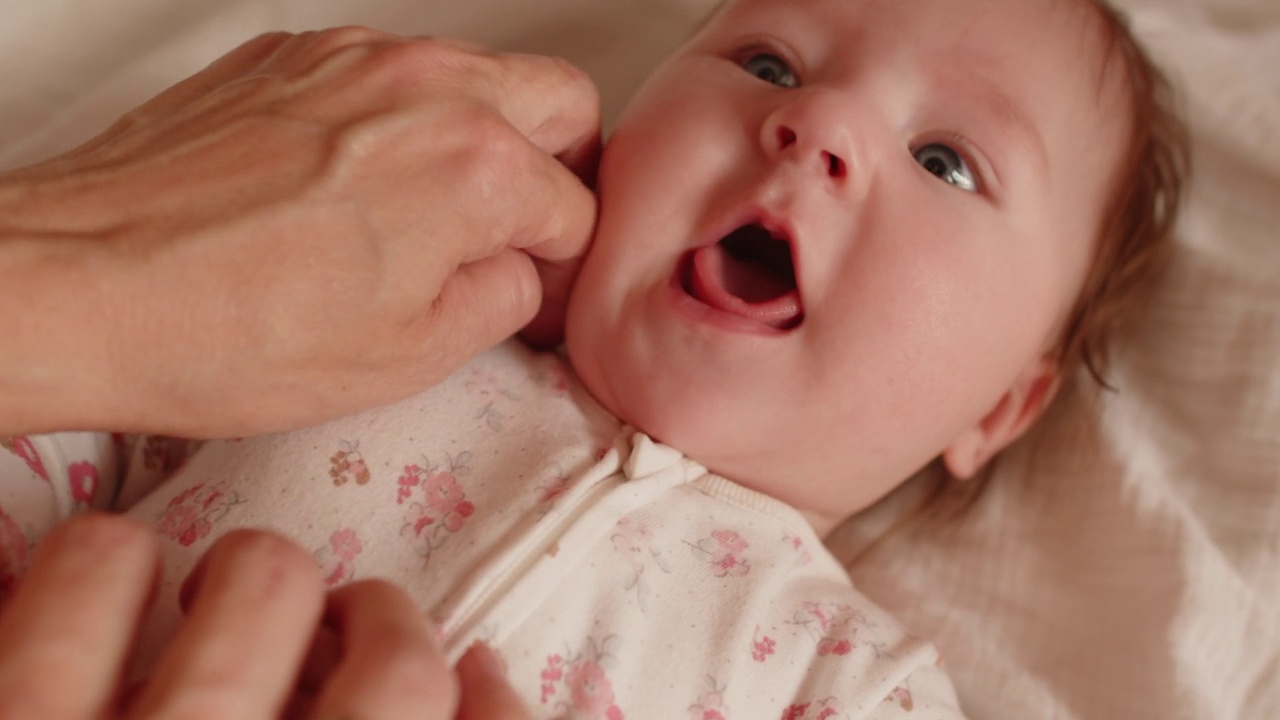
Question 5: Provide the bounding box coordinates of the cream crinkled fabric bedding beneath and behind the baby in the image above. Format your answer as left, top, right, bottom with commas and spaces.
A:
0, 0, 1280, 719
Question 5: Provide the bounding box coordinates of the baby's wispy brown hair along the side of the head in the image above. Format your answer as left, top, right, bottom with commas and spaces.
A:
1055, 0, 1190, 389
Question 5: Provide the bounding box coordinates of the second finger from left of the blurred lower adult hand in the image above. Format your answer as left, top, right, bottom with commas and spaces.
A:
126, 530, 324, 720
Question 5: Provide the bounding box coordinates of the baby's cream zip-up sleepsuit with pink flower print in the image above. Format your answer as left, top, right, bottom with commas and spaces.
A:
0, 342, 960, 720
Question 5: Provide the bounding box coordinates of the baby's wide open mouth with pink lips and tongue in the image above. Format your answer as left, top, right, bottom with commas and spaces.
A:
681, 223, 804, 331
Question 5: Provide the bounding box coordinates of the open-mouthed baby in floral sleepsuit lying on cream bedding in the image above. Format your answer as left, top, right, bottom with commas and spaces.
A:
0, 0, 1178, 720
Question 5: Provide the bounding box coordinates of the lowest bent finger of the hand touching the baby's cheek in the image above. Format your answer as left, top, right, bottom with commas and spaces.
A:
424, 249, 541, 374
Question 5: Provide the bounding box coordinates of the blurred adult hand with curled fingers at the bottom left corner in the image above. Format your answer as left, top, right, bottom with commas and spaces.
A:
0, 515, 527, 720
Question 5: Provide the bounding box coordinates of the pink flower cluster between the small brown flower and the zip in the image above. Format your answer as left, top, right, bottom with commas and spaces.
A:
396, 452, 476, 557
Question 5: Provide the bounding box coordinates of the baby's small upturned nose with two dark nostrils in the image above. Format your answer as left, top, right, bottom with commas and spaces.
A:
760, 90, 855, 184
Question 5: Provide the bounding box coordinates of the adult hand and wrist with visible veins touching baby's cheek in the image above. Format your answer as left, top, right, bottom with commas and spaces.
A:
0, 28, 599, 437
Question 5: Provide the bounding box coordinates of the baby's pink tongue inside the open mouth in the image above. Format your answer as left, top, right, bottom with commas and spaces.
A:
690, 245, 801, 329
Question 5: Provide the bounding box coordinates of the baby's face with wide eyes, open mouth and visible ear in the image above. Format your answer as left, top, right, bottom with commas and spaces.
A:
568, 0, 1126, 525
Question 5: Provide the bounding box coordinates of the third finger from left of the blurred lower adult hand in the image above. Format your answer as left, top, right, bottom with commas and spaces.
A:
305, 580, 457, 720
